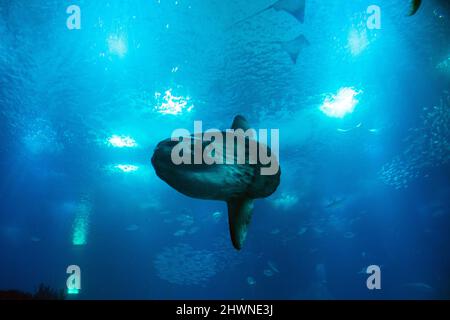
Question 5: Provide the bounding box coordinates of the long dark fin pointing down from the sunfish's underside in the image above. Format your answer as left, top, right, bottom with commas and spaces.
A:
227, 198, 253, 250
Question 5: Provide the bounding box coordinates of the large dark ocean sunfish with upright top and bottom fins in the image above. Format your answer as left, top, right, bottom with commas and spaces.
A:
152, 116, 281, 250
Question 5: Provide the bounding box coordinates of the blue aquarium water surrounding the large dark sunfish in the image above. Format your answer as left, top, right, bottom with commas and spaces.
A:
0, 0, 450, 299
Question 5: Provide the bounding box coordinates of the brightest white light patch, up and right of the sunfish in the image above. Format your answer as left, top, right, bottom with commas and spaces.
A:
320, 87, 362, 118
